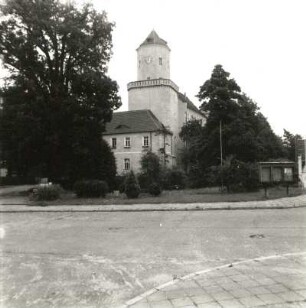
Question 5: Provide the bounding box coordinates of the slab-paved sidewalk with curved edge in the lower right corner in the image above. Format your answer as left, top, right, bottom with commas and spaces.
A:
121, 252, 306, 308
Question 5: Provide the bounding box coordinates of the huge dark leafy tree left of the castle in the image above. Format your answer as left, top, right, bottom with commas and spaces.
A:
0, 0, 121, 180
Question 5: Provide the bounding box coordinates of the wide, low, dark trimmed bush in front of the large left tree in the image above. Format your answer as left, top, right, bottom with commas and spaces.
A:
74, 180, 108, 198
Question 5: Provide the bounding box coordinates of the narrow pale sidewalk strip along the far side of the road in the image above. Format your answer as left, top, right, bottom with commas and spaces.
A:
0, 195, 306, 212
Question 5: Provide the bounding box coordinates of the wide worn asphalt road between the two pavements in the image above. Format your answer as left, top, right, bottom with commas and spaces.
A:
0, 208, 306, 308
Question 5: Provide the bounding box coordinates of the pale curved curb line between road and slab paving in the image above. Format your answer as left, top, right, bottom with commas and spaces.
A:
117, 251, 306, 308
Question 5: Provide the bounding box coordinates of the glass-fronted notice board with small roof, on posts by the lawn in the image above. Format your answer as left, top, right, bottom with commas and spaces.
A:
259, 161, 296, 184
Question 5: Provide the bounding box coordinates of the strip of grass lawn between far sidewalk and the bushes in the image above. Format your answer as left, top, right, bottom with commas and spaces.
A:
41, 187, 305, 205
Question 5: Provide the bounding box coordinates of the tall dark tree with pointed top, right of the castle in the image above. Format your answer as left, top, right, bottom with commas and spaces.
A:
198, 65, 283, 166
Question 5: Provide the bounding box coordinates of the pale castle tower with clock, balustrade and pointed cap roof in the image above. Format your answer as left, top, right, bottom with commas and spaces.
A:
128, 30, 180, 135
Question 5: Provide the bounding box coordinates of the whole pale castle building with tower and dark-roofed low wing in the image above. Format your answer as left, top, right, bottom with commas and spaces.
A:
103, 30, 205, 174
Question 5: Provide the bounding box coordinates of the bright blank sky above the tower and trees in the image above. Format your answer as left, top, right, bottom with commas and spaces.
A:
92, 0, 306, 136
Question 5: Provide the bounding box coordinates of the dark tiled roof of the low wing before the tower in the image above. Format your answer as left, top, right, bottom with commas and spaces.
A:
103, 109, 171, 135
